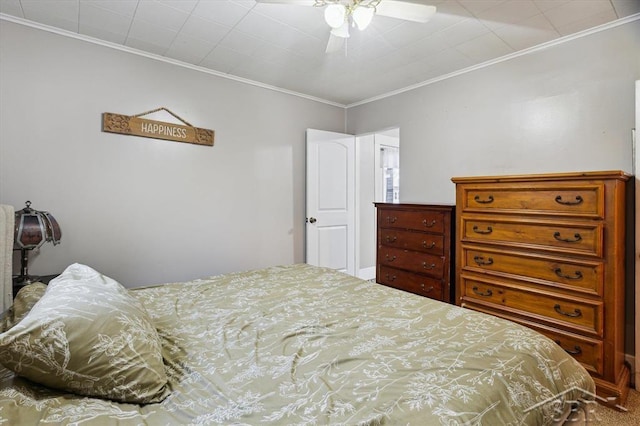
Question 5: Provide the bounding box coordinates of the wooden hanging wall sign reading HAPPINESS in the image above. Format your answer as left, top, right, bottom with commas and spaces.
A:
102, 107, 214, 146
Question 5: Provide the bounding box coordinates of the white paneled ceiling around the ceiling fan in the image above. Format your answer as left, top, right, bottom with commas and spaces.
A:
0, 0, 640, 105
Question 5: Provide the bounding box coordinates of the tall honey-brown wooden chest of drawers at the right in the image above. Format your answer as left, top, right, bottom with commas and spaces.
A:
452, 171, 630, 406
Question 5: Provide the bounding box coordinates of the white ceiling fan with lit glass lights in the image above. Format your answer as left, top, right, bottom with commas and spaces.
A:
256, 0, 436, 52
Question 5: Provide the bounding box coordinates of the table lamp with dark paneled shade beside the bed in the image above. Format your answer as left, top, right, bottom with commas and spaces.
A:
14, 201, 62, 283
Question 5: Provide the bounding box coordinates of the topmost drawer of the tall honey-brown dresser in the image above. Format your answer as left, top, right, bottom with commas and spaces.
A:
462, 182, 604, 218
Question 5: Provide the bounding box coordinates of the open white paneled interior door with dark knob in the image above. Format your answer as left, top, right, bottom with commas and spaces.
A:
306, 129, 356, 275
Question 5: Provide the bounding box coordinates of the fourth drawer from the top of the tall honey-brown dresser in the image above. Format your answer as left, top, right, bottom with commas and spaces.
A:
461, 276, 603, 336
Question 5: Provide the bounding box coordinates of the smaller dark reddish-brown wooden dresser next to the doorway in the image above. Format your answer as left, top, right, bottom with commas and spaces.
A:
375, 203, 455, 302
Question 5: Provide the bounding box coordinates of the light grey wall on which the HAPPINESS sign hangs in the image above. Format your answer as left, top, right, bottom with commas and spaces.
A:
0, 21, 344, 286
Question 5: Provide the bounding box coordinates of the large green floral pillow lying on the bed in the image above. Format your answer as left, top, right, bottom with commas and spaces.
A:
0, 263, 168, 404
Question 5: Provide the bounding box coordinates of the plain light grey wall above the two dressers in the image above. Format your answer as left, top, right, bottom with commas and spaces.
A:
347, 20, 640, 203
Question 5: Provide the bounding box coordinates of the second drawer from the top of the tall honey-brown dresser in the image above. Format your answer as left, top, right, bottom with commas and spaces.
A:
461, 216, 603, 257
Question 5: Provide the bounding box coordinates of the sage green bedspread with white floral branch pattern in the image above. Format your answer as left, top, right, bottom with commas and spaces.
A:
0, 264, 595, 426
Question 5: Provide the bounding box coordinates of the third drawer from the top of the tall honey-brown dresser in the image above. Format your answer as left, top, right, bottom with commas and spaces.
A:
461, 246, 604, 296
